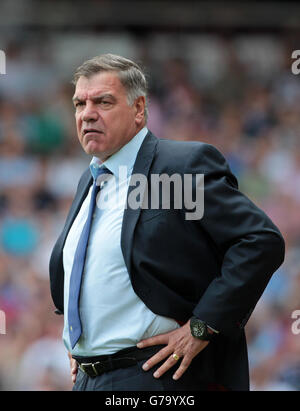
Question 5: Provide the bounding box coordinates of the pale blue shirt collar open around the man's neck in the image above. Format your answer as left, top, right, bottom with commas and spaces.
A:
90, 127, 148, 179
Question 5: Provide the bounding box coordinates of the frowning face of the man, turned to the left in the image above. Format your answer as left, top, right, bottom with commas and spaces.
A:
73, 72, 145, 161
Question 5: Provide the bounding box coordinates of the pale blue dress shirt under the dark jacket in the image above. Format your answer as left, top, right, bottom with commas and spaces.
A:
63, 128, 179, 356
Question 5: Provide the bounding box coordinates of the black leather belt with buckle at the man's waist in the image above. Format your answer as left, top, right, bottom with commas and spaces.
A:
72, 345, 165, 378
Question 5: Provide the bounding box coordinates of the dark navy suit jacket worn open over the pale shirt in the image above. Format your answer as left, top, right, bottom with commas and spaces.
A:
50, 132, 284, 390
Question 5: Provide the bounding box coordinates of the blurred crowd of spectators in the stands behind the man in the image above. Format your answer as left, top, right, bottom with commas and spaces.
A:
0, 32, 300, 391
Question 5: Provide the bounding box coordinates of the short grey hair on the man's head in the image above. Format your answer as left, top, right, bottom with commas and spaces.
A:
72, 53, 148, 121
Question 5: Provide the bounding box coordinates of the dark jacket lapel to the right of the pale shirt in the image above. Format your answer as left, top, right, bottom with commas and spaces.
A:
121, 132, 158, 275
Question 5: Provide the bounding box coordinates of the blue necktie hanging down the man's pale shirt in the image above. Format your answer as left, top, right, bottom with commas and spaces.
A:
68, 167, 112, 348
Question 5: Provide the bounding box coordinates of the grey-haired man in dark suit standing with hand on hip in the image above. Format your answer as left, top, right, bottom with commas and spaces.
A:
50, 54, 284, 391
